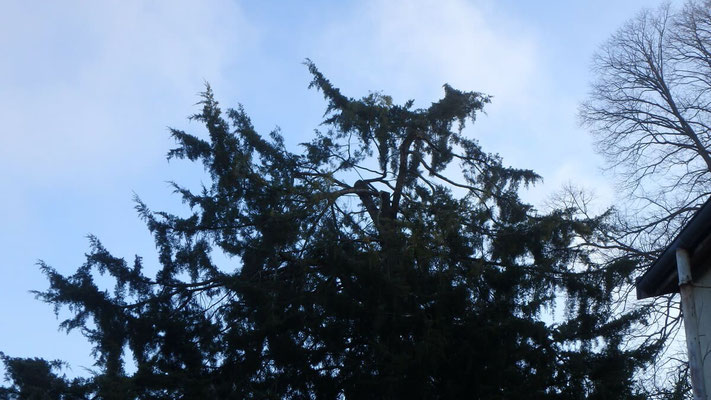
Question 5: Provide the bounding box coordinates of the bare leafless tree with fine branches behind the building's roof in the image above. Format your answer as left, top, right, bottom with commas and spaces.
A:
580, 1, 711, 398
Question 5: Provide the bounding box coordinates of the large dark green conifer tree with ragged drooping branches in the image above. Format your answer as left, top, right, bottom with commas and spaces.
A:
5, 62, 648, 399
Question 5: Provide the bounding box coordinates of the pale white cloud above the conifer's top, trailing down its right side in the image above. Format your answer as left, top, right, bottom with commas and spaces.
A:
308, 0, 550, 167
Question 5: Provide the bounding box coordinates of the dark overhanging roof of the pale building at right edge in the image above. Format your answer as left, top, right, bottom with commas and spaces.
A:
635, 198, 711, 299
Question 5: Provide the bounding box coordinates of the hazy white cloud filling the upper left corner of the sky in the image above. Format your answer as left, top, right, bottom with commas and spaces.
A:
0, 0, 255, 183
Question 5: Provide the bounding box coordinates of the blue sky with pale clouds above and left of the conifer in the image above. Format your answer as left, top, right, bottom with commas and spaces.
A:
0, 0, 654, 374
